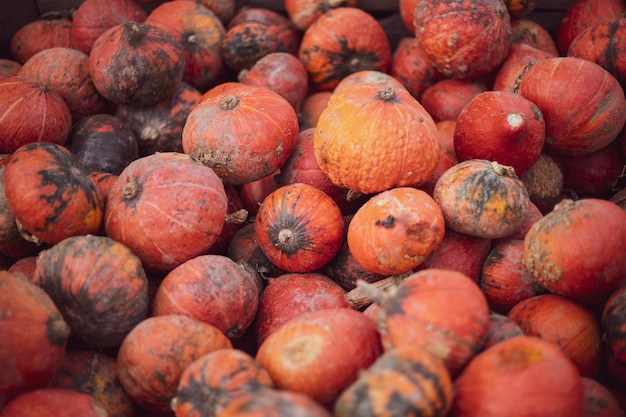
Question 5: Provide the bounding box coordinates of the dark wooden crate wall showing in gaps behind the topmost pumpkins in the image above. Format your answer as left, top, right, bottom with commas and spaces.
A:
0, 0, 574, 58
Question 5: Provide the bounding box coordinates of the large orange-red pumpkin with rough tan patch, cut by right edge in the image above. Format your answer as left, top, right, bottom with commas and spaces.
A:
523, 198, 626, 305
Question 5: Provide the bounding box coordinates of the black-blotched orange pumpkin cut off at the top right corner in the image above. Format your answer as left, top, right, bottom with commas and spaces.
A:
567, 18, 626, 88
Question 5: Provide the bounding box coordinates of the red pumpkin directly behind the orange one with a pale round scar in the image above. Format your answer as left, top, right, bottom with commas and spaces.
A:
252, 272, 350, 347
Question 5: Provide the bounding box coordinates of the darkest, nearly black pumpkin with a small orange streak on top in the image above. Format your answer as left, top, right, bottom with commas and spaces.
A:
67, 114, 139, 175
